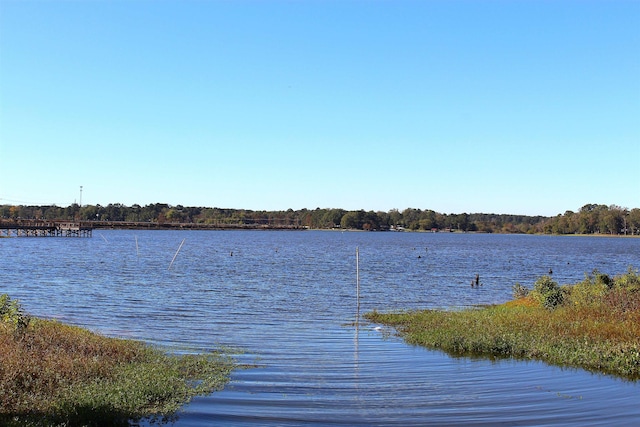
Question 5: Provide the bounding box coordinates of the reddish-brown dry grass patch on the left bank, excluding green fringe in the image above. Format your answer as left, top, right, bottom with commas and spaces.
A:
0, 319, 146, 413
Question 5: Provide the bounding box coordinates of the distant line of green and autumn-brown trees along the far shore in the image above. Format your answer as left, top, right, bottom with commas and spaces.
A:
0, 203, 640, 235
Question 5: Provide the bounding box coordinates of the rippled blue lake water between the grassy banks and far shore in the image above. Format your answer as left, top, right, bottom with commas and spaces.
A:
0, 230, 640, 427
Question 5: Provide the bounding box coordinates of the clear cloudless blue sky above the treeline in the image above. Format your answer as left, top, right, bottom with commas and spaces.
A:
0, 0, 640, 215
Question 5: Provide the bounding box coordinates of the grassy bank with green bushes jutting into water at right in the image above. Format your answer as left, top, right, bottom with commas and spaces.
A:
365, 269, 640, 380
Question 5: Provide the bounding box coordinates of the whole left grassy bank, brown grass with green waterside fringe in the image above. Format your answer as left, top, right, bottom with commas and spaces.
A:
0, 295, 234, 426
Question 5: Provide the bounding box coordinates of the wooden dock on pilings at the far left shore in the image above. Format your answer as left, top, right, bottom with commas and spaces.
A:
0, 219, 93, 237
